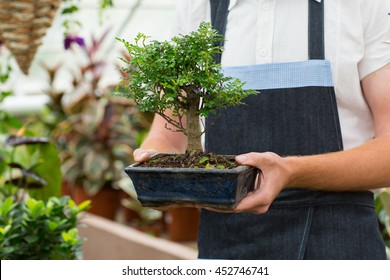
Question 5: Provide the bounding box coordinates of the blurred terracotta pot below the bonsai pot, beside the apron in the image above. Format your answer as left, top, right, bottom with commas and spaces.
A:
164, 207, 200, 241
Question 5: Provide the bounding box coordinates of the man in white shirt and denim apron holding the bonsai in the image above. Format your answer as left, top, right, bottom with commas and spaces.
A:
134, 0, 390, 259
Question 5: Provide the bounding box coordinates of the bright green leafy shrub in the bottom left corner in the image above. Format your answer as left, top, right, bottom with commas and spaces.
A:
0, 197, 89, 260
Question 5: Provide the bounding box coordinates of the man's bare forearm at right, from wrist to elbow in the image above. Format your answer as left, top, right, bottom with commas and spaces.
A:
285, 135, 390, 191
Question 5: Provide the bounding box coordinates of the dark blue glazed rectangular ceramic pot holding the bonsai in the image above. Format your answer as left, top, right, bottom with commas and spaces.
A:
125, 155, 258, 210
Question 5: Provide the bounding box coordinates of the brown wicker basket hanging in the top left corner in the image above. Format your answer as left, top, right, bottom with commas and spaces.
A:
0, 0, 61, 74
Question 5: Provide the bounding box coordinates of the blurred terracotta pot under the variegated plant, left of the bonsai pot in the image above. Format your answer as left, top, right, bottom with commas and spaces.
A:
72, 187, 120, 220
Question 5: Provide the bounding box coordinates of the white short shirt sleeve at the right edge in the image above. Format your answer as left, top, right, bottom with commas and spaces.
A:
359, 0, 390, 79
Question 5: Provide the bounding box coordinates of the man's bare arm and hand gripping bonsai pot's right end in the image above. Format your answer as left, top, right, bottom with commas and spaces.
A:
236, 64, 390, 213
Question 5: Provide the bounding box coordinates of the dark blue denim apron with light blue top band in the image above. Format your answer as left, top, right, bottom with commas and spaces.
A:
198, 0, 386, 259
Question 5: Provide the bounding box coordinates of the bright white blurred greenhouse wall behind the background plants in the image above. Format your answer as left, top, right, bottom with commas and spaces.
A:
0, 0, 176, 113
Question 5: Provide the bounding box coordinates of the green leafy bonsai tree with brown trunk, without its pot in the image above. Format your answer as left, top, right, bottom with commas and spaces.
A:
118, 22, 255, 152
